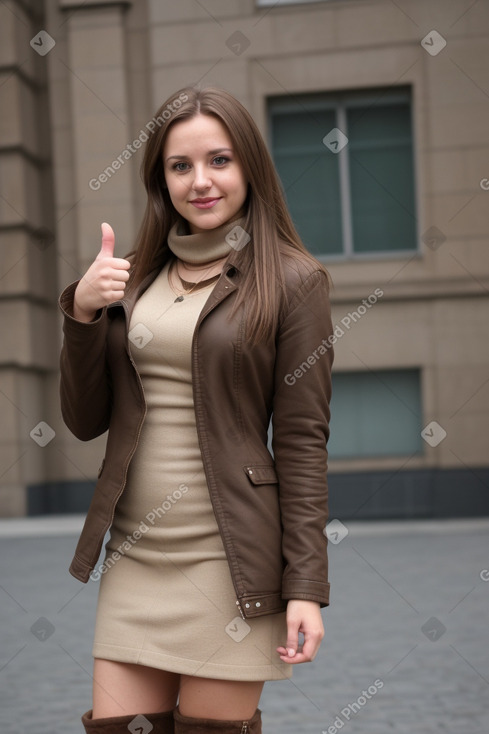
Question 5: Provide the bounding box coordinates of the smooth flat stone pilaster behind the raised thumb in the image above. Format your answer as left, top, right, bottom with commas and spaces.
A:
42, 0, 135, 512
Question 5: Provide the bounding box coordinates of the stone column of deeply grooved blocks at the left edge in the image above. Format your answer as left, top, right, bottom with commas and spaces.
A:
0, 0, 56, 516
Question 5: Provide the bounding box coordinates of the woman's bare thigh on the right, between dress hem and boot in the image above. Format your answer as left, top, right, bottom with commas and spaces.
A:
178, 675, 264, 721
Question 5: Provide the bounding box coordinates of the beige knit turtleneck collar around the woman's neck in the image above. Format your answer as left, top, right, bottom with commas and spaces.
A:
168, 211, 246, 265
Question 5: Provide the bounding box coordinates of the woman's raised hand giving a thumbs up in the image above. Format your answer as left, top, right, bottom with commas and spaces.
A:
73, 222, 131, 322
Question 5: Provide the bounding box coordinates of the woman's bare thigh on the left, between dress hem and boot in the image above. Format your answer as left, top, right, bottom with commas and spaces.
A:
93, 658, 180, 719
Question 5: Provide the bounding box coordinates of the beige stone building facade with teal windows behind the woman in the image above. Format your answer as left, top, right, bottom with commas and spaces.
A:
0, 0, 489, 519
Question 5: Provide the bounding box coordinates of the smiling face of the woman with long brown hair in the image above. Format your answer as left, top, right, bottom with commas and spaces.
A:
163, 114, 247, 234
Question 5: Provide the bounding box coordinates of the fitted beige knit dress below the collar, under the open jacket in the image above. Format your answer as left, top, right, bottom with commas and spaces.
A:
92, 221, 292, 680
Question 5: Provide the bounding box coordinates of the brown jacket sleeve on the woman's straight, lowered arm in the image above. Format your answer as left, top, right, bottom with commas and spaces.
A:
272, 270, 334, 607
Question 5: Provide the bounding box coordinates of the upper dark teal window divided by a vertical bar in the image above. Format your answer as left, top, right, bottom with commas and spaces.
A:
269, 88, 417, 258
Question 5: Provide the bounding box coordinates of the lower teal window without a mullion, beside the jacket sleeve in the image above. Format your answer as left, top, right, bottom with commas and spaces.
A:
328, 369, 424, 459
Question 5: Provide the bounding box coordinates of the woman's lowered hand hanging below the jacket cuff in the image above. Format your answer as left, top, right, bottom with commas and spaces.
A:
277, 599, 324, 664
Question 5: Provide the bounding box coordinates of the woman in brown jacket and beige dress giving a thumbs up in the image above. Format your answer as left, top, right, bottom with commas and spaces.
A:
56, 87, 334, 734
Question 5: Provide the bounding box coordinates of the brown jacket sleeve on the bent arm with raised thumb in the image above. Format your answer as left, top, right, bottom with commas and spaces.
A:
58, 281, 112, 441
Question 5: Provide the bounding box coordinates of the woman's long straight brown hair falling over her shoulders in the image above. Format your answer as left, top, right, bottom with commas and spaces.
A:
127, 87, 331, 343
